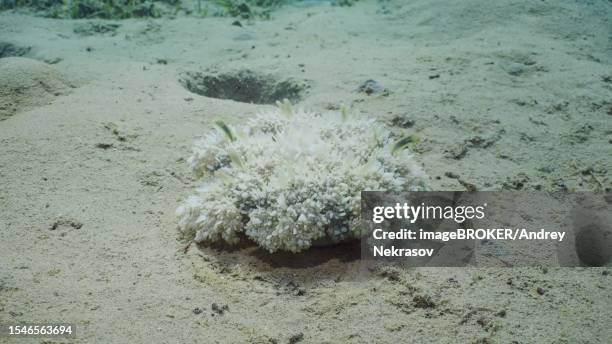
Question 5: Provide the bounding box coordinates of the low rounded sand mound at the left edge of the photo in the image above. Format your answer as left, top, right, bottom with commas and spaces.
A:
0, 57, 70, 121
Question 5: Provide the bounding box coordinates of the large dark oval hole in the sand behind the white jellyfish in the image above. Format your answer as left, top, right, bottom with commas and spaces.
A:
180, 70, 308, 104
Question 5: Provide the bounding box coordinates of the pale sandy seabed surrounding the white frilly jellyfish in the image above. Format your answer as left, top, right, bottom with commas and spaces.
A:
0, 0, 612, 343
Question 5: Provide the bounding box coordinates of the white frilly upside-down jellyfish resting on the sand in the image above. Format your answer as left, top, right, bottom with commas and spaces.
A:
177, 103, 426, 252
